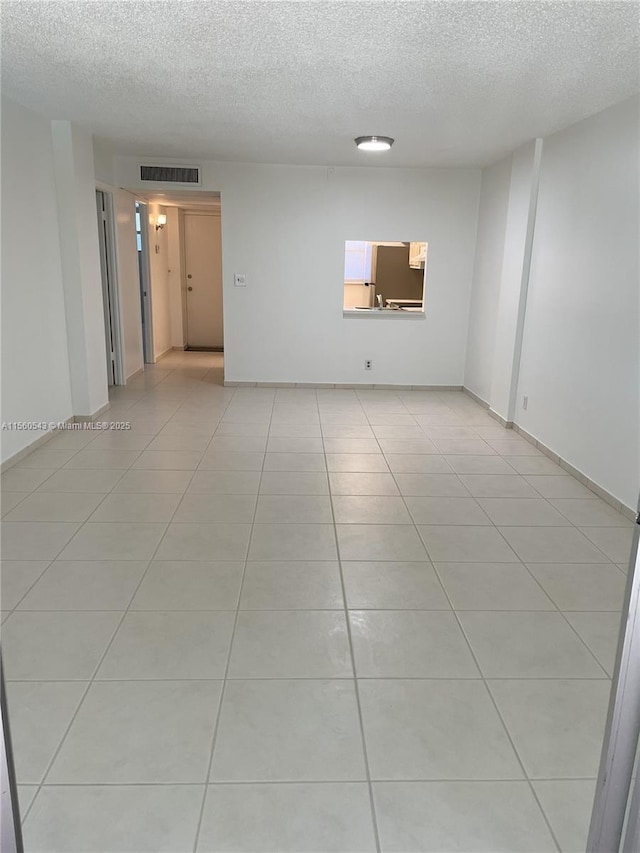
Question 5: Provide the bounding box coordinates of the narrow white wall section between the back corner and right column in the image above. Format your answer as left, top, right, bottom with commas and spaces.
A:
465, 154, 513, 402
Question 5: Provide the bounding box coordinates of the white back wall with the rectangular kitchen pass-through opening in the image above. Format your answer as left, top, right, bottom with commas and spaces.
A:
116, 157, 480, 385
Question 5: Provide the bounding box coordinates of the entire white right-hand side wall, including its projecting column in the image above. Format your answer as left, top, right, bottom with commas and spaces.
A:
465, 98, 640, 507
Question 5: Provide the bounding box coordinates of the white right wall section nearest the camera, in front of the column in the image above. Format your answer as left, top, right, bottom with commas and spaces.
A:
517, 98, 640, 507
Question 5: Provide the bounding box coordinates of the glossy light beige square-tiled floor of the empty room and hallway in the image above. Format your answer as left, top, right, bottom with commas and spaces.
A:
2, 353, 632, 853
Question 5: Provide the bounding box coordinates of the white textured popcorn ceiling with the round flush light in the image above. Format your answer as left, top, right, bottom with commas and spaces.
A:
0, 0, 639, 166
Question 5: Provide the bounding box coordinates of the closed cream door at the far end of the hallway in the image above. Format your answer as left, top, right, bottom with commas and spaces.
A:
184, 213, 223, 349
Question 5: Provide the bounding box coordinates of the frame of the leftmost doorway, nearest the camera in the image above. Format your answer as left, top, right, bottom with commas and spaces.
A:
95, 191, 126, 385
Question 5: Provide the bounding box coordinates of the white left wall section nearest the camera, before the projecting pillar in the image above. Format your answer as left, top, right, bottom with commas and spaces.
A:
1, 98, 74, 460
